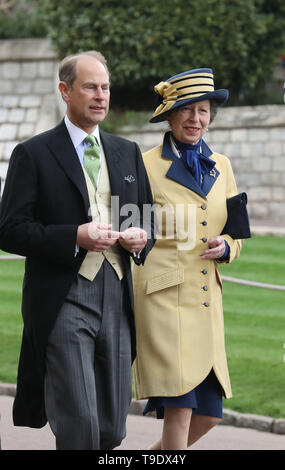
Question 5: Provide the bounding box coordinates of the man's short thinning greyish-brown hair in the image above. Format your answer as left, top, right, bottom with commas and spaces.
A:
59, 51, 109, 88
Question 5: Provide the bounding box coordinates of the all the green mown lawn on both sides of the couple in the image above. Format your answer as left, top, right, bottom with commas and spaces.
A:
0, 236, 285, 418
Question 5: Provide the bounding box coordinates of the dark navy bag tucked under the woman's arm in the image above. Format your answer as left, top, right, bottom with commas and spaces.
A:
221, 193, 251, 239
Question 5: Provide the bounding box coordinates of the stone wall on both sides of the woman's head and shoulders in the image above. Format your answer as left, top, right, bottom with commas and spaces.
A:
123, 105, 285, 222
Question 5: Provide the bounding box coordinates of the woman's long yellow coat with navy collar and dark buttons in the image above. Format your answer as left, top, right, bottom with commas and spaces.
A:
133, 134, 242, 399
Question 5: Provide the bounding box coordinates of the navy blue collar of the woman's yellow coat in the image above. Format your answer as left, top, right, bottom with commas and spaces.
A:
161, 132, 220, 198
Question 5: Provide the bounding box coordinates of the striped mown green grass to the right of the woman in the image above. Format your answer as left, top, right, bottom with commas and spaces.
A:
220, 237, 285, 418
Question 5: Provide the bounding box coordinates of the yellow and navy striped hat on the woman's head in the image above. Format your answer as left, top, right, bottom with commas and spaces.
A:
149, 69, 229, 122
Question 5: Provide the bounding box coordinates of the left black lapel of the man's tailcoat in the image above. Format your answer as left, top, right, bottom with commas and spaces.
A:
49, 121, 90, 218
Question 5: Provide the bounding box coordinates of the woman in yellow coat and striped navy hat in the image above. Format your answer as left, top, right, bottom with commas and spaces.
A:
133, 69, 242, 449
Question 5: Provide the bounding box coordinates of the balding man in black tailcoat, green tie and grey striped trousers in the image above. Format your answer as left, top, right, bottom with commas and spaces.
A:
0, 51, 153, 450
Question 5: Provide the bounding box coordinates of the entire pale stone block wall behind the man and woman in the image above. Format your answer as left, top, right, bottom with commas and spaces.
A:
0, 39, 285, 226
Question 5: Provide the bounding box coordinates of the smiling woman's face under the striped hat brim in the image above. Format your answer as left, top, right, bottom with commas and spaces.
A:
167, 100, 210, 145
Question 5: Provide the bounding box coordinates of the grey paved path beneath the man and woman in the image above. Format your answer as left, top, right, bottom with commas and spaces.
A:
0, 396, 285, 450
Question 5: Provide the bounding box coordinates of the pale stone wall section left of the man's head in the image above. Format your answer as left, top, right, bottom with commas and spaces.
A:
0, 39, 57, 187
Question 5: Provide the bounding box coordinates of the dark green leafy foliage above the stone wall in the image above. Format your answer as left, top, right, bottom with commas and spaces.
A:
39, 0, 285, 106
